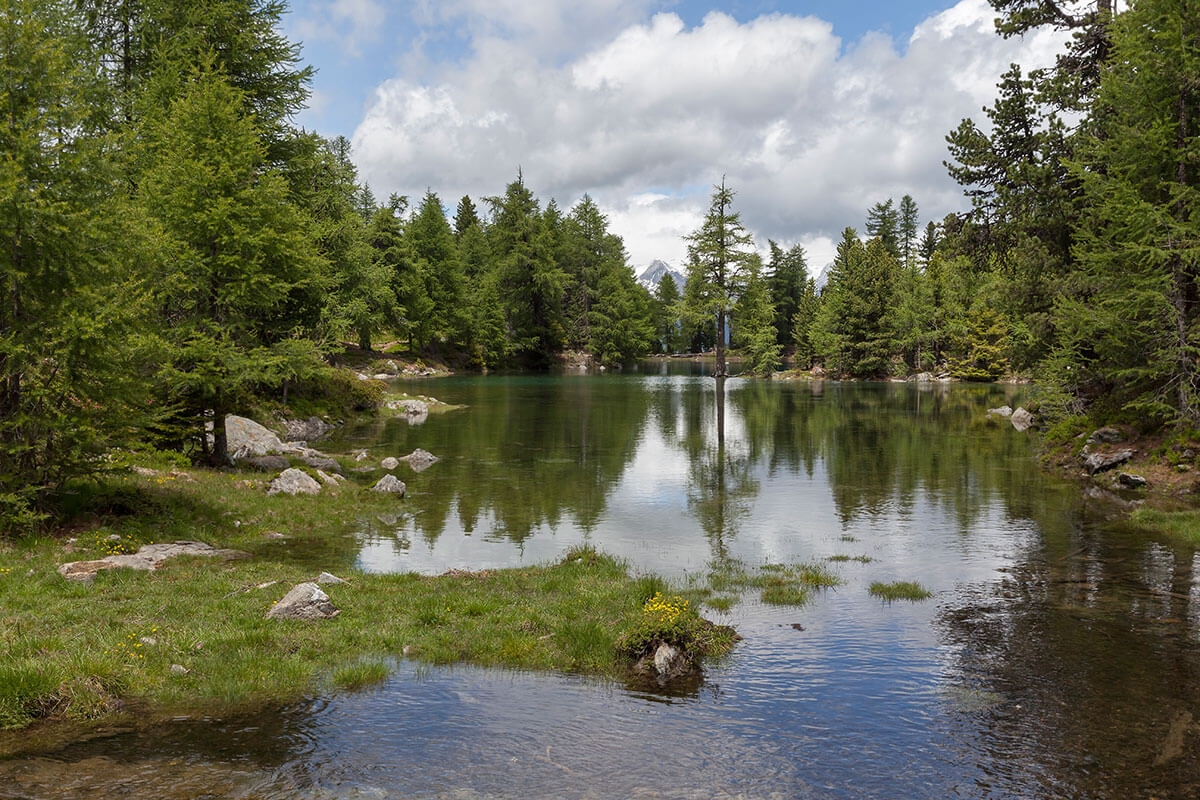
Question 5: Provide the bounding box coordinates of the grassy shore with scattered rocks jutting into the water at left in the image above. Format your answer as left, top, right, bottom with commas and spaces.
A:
0, 464, 733, 743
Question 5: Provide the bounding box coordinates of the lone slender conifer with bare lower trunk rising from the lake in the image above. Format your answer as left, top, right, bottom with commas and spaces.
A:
684, 178, 754, 378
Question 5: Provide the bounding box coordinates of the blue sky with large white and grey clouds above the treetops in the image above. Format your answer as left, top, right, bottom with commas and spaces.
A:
284, 0, 1061, 273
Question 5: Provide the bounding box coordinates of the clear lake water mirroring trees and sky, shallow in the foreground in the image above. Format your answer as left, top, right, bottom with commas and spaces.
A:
0, 365, 1200, 799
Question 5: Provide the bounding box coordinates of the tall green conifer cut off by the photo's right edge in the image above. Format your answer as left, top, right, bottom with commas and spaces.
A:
1058, 0, 1200, 427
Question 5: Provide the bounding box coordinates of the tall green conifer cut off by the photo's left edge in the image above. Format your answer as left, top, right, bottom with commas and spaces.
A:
0, 0, 144, 533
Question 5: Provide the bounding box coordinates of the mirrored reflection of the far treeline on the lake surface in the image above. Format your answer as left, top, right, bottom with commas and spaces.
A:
343, 375, 1044, 558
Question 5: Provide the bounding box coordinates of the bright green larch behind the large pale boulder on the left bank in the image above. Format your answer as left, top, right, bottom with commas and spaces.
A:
139, 68, 322, 463
